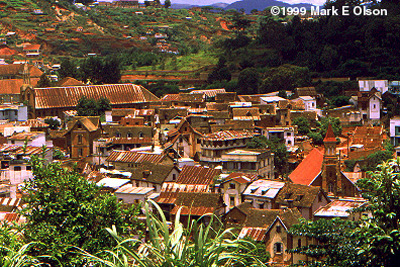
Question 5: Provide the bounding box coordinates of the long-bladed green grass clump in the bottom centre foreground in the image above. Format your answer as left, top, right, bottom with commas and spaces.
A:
80, 201, 265, 267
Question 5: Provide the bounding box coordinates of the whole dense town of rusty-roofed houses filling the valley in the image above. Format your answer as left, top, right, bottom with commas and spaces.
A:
0, 64, 392, 264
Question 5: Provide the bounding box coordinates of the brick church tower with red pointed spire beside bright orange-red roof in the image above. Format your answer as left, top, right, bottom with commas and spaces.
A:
322, 124, 342, 196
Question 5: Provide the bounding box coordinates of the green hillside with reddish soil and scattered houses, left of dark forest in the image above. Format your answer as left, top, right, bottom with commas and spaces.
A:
0, 0, 238, 63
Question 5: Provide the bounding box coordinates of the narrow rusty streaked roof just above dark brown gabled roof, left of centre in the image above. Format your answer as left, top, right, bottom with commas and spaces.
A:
106, 151, 165, 163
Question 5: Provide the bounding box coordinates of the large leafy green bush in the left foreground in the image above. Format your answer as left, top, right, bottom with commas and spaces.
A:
22, 157, 143, 266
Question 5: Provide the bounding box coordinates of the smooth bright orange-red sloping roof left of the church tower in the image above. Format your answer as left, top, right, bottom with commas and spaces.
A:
289, 148, 324, 185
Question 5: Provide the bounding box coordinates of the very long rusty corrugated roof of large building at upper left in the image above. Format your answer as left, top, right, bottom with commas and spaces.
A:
35, 84, 159, 109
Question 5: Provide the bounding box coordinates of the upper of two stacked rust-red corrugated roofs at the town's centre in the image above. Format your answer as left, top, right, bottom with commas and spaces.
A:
176, 165, 221, 185
